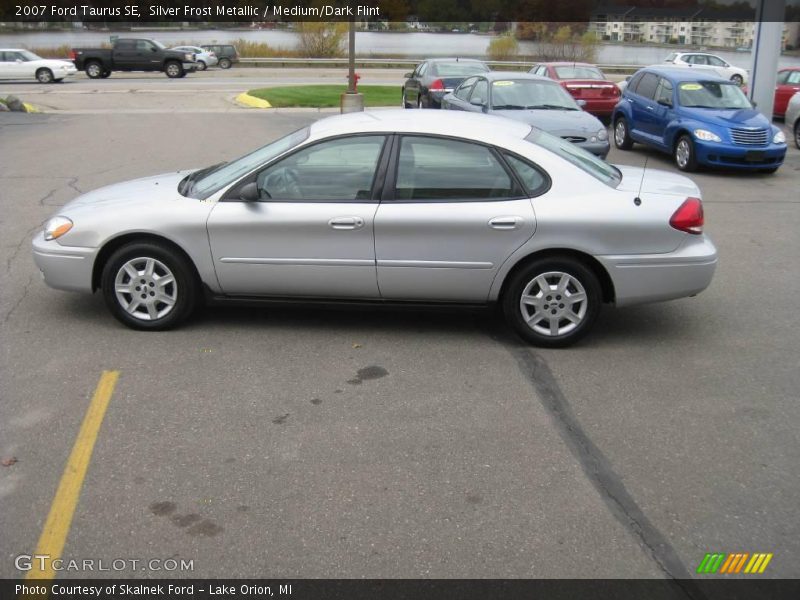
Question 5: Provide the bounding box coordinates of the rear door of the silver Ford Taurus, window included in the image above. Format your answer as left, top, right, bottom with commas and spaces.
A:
375, 135, 544, 303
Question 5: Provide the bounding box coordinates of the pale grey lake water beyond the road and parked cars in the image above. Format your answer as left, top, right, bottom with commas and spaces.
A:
0, 29, 800, 68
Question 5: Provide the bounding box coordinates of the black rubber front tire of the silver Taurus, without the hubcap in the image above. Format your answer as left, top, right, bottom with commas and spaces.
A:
100, 242, 198, 331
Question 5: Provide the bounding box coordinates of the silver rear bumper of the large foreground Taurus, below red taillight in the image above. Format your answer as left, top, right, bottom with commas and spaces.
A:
597, 234, 717, 306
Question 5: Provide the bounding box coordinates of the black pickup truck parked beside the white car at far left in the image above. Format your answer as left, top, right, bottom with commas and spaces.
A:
70, 38, 198, 79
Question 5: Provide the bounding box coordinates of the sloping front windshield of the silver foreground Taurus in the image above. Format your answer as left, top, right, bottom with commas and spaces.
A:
185, 127, 309, 200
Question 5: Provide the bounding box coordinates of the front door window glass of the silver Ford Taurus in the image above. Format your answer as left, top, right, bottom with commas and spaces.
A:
256, 135, 386, 202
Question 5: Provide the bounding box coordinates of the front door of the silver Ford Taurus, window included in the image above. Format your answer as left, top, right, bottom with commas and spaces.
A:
208, 135, 388, 299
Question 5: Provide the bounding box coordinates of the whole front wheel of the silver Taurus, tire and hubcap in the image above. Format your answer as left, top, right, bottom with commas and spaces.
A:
101, 242, 199, 331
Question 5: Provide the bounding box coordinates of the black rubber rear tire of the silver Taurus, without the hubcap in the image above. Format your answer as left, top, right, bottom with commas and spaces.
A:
502, 257, 603, 348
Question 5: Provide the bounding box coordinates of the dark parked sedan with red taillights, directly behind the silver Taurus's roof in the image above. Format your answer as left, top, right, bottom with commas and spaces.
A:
402, 58, 489, 108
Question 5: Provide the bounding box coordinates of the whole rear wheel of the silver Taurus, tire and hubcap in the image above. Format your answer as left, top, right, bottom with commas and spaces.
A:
502, 257, 602, 348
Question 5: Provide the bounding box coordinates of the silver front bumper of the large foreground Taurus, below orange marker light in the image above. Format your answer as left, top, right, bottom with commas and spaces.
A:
33, 232, 97, 292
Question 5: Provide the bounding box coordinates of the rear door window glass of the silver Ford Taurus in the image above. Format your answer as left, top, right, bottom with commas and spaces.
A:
395, 136, 518, 201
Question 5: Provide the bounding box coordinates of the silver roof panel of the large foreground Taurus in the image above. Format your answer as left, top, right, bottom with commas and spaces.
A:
310, 108, 531, 143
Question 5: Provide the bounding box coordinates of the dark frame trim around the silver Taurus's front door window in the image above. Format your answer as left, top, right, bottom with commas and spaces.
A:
219, 131, 394, 204
